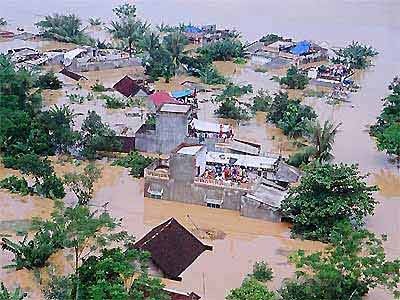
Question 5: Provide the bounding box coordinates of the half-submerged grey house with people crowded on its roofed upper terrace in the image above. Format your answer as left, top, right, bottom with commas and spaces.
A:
144, 144, 298, 221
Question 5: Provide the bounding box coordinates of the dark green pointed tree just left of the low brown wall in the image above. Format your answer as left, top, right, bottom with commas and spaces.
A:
79, 111, 121, 159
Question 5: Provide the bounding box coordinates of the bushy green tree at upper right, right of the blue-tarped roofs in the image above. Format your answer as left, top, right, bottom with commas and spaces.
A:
333, 41, 379, 69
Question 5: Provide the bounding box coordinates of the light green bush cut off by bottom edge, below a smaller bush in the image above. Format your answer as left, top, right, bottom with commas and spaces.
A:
225, 277, 277, 300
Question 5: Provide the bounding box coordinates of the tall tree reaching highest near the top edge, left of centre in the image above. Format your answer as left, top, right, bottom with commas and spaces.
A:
108, 3, 149, 56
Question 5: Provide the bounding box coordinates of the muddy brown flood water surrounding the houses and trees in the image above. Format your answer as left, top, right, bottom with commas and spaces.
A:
0, 0, 400, 300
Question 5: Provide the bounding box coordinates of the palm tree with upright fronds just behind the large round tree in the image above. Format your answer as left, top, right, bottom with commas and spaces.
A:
308, 121, 342, 162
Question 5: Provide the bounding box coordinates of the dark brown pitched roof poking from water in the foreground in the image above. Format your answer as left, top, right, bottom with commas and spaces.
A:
134, 218, 212, 280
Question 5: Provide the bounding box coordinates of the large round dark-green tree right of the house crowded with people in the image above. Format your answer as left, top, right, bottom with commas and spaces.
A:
281, 164, 377, 241
